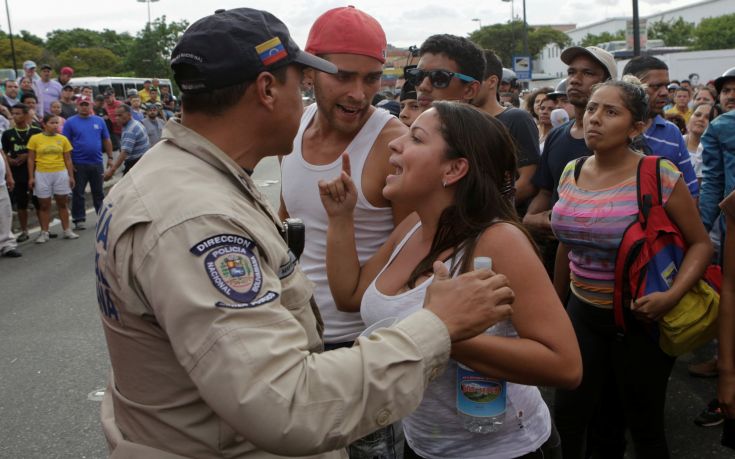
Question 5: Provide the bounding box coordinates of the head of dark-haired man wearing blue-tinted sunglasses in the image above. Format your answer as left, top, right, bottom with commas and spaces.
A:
406, 34, 485, 111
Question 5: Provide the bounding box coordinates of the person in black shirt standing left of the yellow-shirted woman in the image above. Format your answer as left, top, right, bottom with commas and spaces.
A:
0, 103, 41, 242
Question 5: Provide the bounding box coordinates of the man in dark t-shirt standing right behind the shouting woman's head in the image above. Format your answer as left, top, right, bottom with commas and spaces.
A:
472, 50, 540, 208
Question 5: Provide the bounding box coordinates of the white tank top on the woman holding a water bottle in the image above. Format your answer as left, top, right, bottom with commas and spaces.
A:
360, 222, 551, 459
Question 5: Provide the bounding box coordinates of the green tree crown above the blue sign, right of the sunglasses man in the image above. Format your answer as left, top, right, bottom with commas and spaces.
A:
469, 21, 570, 67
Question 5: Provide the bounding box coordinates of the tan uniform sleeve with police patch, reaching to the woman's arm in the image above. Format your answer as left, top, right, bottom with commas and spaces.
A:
135, 217, 450, 456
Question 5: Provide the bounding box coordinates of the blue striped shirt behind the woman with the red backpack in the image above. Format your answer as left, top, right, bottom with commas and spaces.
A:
643, 115, 699, 198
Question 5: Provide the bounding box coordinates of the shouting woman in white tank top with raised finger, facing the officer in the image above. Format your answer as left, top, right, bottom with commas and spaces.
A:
319, 102, 581, 459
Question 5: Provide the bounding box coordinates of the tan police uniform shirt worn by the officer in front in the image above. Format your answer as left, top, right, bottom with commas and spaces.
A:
96, 121, 450, 458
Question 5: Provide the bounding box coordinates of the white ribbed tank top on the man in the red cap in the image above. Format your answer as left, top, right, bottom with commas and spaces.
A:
281, 104, 394, 343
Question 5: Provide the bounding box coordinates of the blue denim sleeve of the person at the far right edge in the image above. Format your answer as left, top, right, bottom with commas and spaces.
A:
699, 123, 725, 231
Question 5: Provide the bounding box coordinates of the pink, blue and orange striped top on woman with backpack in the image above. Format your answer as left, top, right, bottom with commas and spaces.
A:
551, 160, 681, 309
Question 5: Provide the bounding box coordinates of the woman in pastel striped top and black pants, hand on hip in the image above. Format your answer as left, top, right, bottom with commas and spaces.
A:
551, 80, 712, 458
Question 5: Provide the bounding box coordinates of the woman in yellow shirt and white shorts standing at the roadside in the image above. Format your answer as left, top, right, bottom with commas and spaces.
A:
28, 113, 79, 244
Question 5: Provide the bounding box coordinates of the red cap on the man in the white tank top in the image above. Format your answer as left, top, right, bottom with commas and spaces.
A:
306, 5, 388, 63
